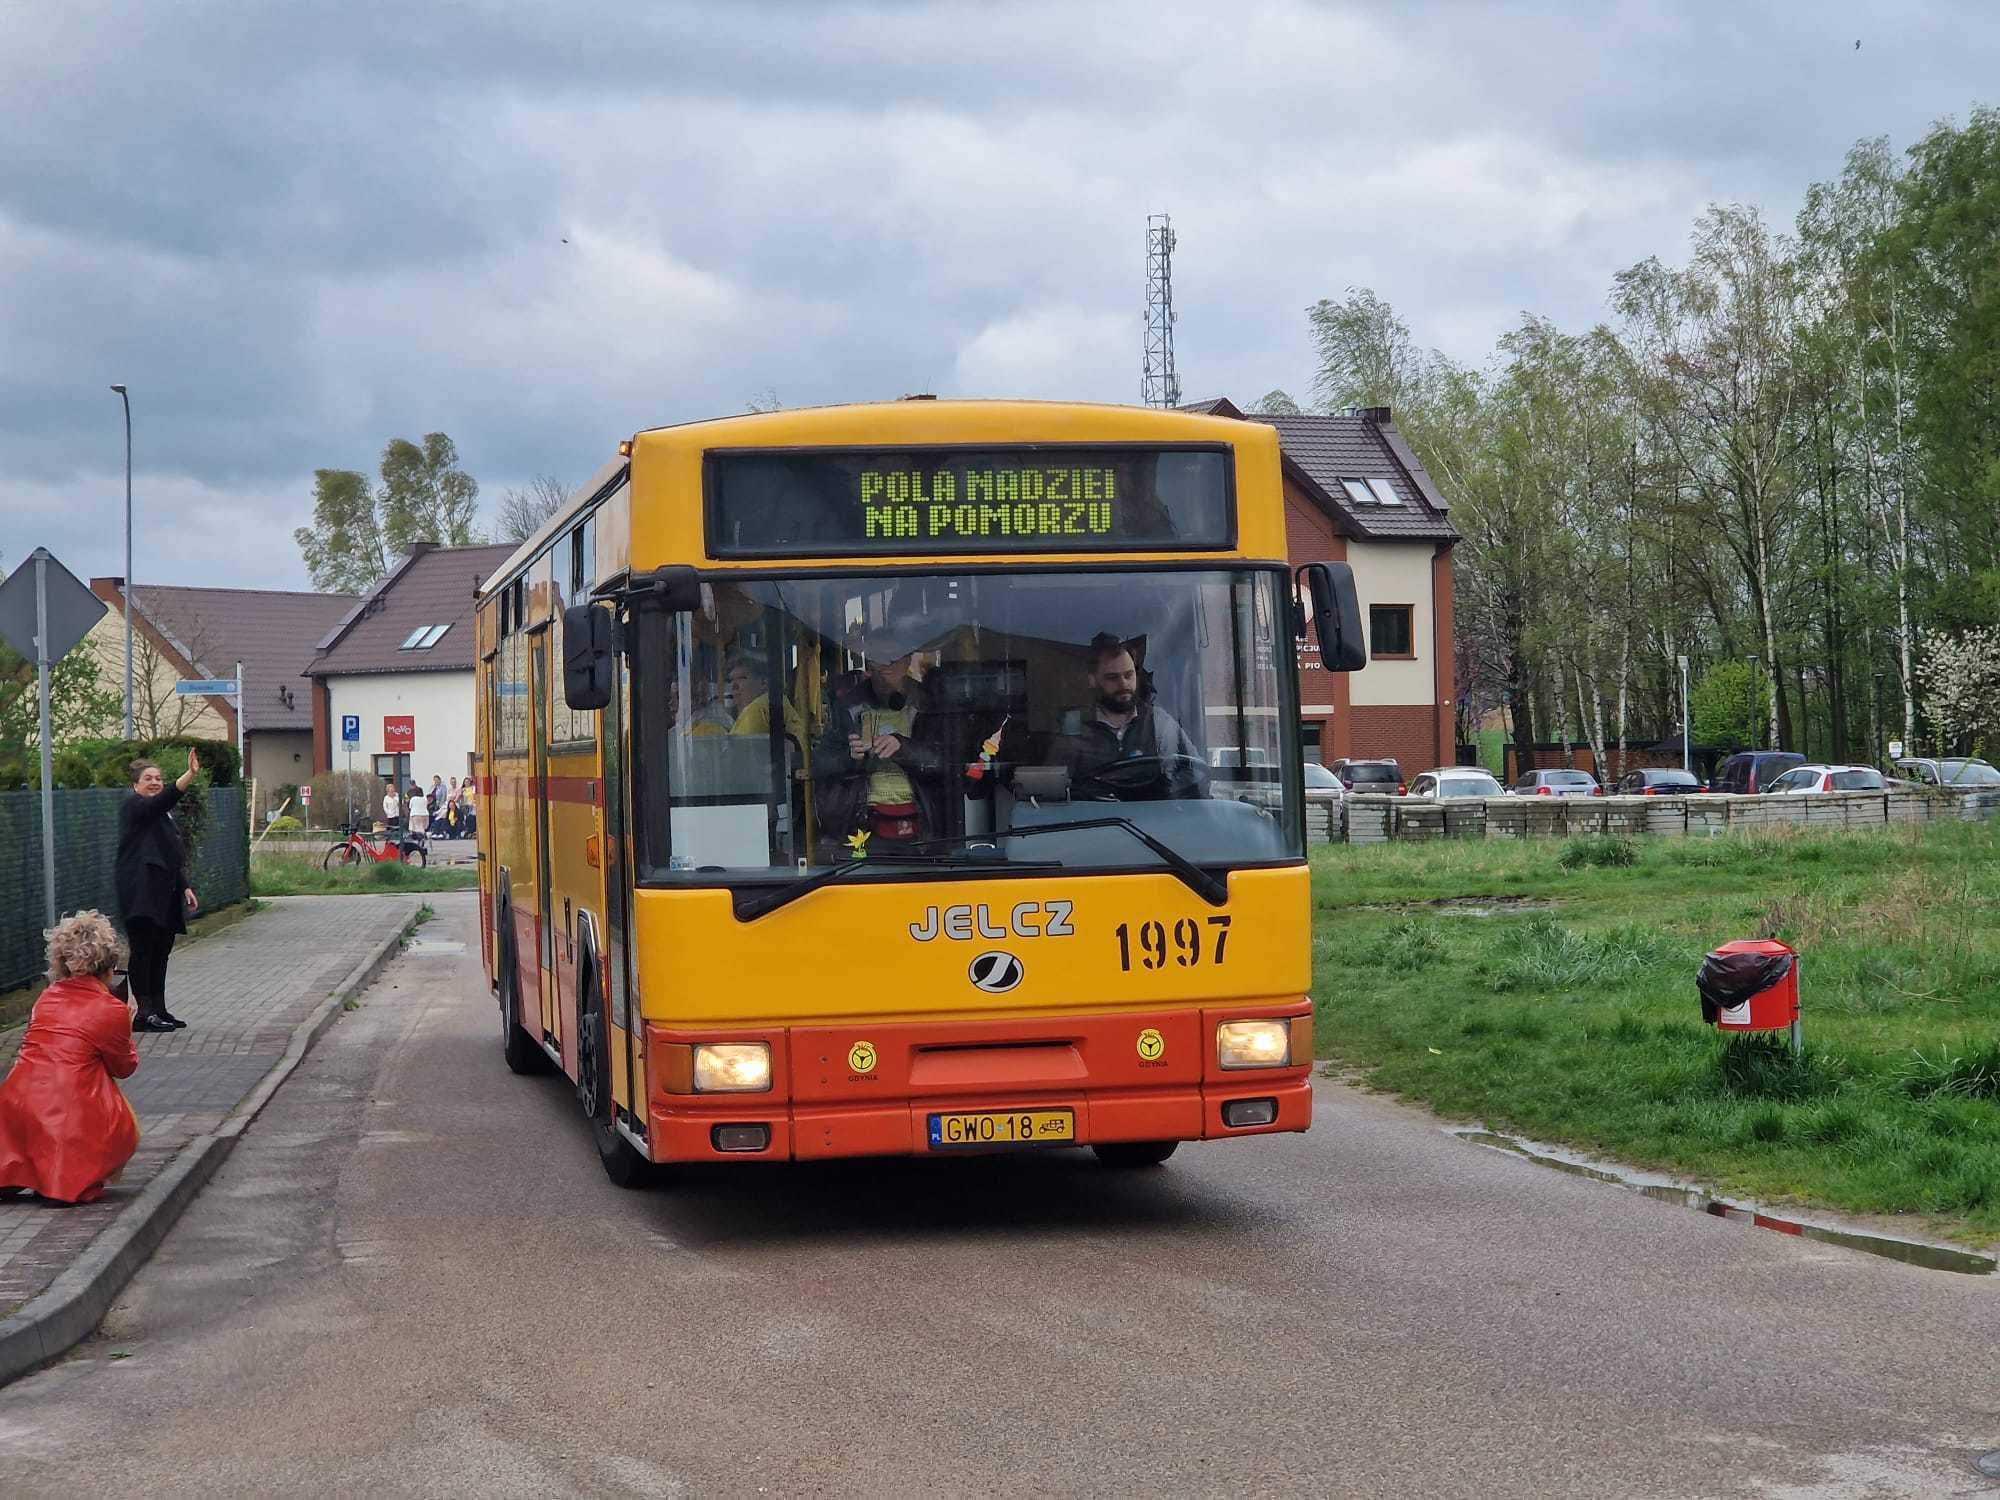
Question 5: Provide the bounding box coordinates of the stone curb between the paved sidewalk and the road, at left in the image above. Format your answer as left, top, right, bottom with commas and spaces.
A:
0, 912, 418, 1386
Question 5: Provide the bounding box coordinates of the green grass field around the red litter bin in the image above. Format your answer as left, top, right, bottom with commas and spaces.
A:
1314, 824, 2000, 1242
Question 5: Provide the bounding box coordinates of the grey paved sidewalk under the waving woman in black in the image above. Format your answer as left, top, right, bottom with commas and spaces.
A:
0, 894, 424, 1320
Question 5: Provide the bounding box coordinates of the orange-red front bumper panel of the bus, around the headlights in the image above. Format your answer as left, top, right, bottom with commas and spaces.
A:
646, 998, 1312, 1162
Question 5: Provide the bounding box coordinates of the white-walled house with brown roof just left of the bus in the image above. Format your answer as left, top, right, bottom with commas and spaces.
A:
300, 542, 514, 800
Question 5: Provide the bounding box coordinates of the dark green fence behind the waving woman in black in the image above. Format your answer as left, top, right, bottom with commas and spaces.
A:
0, 786, 250, 990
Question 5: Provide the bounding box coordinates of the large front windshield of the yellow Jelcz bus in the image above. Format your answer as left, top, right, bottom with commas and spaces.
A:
630, 564, 1304, 884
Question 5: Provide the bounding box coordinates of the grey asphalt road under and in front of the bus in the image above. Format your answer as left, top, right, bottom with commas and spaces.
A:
0, 896, 2000, 1500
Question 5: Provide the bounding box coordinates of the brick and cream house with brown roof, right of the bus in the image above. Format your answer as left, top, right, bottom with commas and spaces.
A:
1184, 398, 1458, 778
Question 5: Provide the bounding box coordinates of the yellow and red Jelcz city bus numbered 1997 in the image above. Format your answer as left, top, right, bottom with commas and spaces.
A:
476, 398, 1364, 1184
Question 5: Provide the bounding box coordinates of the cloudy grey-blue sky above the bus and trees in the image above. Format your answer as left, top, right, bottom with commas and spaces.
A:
0, 0, 2000, 588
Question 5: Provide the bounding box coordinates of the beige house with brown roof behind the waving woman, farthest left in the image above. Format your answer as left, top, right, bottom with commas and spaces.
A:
86, 578, 356, 806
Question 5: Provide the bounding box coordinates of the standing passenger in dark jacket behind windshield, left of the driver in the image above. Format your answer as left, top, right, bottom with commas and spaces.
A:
812, 634, 946, 858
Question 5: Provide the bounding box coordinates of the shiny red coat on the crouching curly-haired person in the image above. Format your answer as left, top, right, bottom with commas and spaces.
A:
0, 978, 138, 1204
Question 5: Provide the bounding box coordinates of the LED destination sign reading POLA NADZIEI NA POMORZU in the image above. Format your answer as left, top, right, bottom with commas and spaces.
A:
708, 446, 1236, 558
